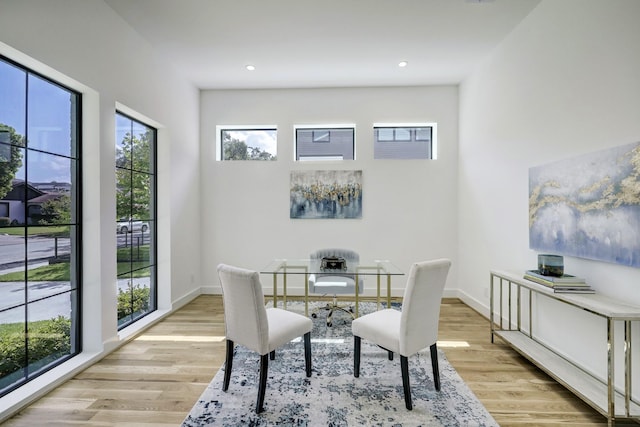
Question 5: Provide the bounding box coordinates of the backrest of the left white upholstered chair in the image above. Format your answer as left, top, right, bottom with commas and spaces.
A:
218, 264, 269, 355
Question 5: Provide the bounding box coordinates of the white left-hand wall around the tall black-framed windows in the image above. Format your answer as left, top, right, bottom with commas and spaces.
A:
0, 0, 200, 417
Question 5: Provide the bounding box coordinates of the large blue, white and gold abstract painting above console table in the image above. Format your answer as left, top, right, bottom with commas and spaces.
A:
529, 143, 640, 267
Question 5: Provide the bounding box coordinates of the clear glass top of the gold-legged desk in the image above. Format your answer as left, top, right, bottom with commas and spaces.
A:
260, 259, 404, 276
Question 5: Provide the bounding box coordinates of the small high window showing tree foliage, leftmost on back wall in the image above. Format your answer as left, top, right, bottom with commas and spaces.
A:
216, 126, 278, 160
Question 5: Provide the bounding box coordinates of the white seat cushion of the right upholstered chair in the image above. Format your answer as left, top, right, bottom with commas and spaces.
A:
351, 308, 402, 353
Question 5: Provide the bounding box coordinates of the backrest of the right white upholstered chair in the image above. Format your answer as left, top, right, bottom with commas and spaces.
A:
400, 259, 451, 356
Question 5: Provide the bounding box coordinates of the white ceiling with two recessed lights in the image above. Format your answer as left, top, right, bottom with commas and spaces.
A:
105, 0, 539, 89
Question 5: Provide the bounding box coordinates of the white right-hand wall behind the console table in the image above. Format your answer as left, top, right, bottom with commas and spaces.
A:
458, 0, 640, 390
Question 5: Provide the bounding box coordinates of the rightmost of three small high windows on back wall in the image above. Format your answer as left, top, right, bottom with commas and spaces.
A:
373, 123, 436, 159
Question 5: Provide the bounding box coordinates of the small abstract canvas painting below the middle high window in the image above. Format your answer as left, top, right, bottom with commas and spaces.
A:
289, 170, 362, 219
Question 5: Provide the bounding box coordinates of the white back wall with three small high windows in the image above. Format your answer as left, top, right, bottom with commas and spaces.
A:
200, 86, 458, 295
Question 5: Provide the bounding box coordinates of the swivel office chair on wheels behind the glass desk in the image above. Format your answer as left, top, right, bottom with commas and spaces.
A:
308, 248, 364, 326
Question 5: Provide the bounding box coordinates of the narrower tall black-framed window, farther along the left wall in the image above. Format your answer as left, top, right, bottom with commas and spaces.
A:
114, 113, 157, 329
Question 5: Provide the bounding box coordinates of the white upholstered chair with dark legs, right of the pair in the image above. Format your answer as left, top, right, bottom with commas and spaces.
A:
351, 259, 451, 410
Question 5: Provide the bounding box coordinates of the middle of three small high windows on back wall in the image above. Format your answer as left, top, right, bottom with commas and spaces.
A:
294, 125, 355, 161
